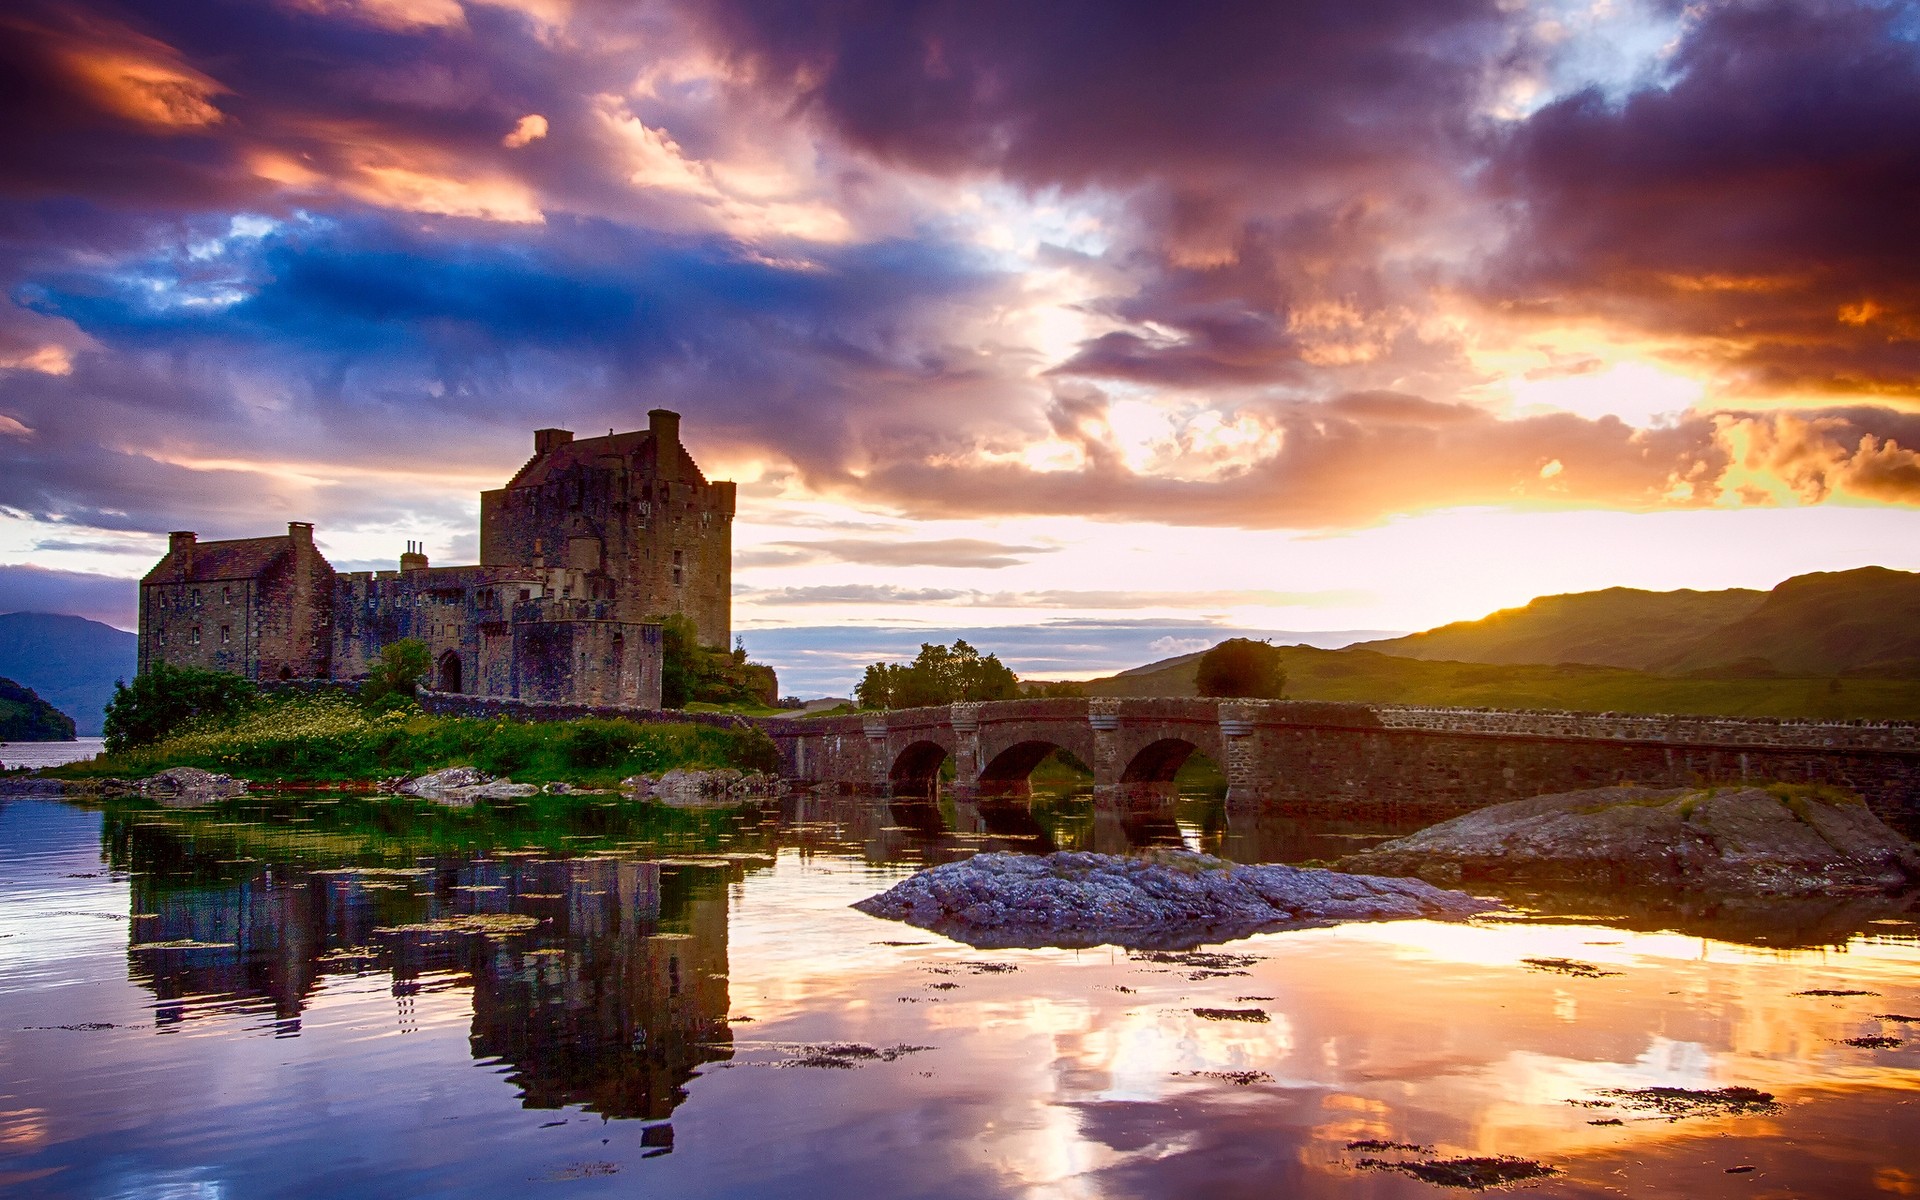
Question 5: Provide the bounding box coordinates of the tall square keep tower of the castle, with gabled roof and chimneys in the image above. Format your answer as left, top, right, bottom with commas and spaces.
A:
480, 409, 733, 647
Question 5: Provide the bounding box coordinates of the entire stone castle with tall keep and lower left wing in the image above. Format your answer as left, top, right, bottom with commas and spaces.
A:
140, 409, 733, 708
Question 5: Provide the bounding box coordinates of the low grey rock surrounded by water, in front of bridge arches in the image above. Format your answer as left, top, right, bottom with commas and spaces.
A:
854, 851, 1500, 950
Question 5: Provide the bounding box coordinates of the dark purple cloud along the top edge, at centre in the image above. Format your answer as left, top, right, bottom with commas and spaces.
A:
695, 0, 1507, 189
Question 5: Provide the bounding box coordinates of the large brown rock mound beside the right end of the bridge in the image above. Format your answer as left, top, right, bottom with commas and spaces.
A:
1340, 787, 1920, 897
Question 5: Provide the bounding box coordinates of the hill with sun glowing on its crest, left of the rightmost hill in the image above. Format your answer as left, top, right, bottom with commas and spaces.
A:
1354, 591, 1758, 674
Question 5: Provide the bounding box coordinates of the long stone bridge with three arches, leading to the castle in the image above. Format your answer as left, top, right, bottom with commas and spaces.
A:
756, 697, 1920, 828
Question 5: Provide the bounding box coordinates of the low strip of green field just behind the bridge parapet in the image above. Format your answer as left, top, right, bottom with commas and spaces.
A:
1087, 645, 1920, 720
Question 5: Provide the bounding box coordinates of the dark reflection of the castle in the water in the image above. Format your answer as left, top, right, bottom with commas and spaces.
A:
108, 818, 739, 1119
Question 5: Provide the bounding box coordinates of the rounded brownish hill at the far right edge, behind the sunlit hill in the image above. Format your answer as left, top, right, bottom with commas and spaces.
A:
1659, 566, 1920, 678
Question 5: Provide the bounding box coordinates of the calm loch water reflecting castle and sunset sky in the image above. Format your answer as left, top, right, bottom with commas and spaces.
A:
0, 797, 1920, 1200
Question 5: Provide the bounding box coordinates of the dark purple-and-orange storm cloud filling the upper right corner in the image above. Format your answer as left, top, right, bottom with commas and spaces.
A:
1490, 0, 1920, 394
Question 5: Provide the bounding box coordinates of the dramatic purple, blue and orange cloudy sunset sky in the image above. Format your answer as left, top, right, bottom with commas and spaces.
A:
0, 0, 1920, 693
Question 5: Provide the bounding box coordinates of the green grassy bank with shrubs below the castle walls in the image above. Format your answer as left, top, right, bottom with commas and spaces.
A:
50, 695, 776, 787
